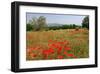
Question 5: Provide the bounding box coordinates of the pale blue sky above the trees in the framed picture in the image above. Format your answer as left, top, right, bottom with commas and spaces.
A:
26, 13, 86, 25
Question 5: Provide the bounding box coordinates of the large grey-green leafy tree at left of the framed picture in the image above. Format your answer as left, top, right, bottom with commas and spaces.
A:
27, 16, 47, 31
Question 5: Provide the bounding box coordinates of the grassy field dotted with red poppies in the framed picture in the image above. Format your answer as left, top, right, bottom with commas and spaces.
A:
26, 29, 89, 60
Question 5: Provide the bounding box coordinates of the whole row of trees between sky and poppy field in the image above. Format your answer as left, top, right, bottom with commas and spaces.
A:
26, 16, 89, 31
